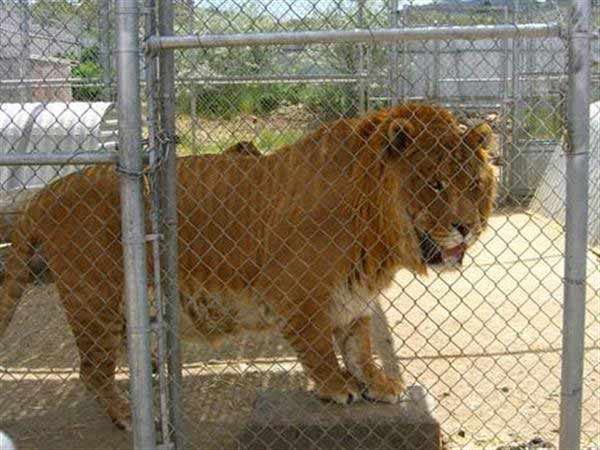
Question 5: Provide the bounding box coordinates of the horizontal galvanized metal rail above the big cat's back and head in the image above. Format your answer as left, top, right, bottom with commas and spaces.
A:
147, 23, 561, 51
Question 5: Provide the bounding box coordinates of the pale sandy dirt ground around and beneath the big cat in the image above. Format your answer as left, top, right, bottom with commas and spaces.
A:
0, 214, 600, 450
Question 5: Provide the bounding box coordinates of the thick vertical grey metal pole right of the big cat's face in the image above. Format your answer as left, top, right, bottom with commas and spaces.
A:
559, 0, 591, 450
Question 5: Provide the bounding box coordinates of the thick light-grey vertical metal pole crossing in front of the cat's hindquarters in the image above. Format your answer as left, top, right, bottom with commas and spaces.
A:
116, 0, 156, 450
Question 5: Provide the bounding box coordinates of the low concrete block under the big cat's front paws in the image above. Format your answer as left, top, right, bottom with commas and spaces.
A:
239, 386, 441, 450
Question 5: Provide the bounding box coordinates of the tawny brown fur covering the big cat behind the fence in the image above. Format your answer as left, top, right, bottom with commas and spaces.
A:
0, 104, 495, 426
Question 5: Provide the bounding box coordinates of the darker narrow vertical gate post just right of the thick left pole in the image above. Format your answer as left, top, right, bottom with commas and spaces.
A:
158, 0, 183, 450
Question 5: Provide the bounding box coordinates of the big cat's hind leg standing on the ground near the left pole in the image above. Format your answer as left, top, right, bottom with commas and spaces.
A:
58, 283, 131, 430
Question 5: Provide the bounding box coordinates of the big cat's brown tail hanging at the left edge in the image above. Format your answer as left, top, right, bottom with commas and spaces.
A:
0, 208, 35, 337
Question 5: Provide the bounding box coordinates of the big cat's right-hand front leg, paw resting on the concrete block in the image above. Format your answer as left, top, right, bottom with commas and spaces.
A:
335, 315, 404, 403
